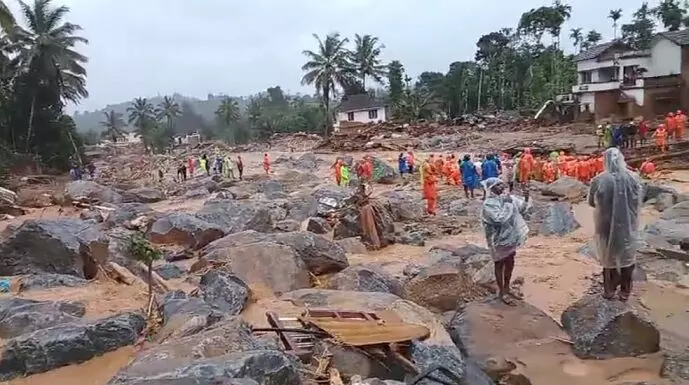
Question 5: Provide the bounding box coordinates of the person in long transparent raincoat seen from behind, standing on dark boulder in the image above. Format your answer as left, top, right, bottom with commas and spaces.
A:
588, 148, 644, 301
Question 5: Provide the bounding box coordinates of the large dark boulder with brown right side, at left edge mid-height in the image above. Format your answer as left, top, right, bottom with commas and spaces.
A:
0, 218, 108, 279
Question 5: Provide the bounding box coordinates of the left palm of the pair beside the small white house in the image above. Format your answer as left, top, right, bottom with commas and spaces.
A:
301, 33, 354, 136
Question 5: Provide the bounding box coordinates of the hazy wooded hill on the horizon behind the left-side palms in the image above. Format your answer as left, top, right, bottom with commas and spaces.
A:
73, 94, 249, 133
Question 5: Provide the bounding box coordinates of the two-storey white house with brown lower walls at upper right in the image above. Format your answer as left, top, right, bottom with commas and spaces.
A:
572, 29, 689, 119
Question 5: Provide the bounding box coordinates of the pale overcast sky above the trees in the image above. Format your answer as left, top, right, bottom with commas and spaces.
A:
6, 0, 657, 110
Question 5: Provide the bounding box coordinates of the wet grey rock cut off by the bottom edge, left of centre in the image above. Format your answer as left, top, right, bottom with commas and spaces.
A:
108, 350, 302, 385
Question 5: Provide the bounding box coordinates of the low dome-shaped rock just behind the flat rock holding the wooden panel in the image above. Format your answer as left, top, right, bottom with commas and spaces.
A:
327, 265, 404, 297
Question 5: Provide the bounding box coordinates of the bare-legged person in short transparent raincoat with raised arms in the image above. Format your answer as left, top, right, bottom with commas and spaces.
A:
481, 178, 529, 305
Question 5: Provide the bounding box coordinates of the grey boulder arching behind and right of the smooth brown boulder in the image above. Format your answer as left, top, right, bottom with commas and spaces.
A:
203, 231, 349, 275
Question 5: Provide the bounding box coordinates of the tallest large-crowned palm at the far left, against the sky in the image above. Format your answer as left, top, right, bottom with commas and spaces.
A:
12, 0, 88, 152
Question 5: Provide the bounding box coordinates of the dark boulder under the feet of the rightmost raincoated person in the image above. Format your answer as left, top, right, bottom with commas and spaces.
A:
562, 296, 660, 359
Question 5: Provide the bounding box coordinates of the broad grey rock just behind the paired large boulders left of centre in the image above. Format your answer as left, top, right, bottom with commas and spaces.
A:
196, 200, 273, 234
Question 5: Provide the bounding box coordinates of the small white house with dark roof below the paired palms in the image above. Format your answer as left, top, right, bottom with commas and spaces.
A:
335, 93, 389, 129
